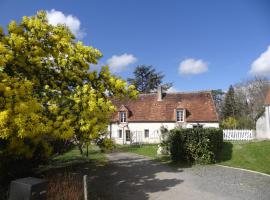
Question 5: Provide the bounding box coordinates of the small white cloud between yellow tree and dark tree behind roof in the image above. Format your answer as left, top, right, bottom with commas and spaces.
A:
107, 53, 137, 72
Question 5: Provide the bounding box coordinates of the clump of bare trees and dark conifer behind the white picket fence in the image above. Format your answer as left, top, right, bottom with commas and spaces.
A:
221, 77, 269, 129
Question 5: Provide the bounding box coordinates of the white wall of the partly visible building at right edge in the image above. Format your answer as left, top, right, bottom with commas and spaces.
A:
256, 106, 270, 139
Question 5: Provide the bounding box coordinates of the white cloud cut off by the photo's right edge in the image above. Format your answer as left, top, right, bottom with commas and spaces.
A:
249, 46, 270, 75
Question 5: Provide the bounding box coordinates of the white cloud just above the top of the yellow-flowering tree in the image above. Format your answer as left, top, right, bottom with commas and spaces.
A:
46, 9, 85, 38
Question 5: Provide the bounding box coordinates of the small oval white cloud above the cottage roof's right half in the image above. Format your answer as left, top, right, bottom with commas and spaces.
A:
178, 58, 208, 75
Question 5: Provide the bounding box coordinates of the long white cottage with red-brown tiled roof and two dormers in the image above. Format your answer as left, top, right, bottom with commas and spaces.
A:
108, 87, 219, 144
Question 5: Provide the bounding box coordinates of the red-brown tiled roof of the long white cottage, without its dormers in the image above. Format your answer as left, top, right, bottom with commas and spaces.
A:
111, 91, 218, 122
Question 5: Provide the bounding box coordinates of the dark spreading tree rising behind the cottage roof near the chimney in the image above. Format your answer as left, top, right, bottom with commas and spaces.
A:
127, 65, 172, 93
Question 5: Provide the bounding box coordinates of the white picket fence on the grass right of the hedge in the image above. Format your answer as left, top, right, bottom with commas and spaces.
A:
223, 129, 255, 140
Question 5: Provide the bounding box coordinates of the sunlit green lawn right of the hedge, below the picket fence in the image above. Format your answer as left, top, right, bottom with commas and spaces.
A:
218, 141, 270, 174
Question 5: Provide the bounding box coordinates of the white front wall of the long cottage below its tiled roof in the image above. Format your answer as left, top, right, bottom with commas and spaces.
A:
108, 122, 219, 144
